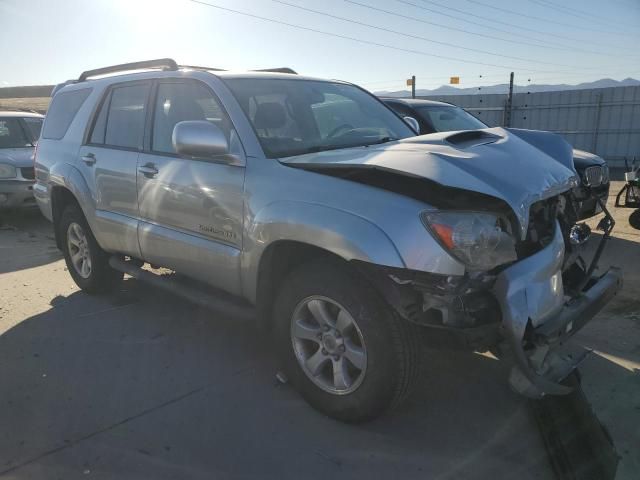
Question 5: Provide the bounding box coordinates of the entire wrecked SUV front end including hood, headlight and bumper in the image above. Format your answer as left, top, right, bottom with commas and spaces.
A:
286, 128, 622, 398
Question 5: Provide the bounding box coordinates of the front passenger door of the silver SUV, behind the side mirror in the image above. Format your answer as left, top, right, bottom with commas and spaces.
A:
138, 79, 244, 294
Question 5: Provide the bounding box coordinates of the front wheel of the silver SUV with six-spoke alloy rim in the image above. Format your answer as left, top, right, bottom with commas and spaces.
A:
273, 259, 421, 423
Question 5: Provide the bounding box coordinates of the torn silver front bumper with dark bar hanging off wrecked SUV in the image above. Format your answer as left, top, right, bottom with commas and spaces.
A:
495, 200, 622, 398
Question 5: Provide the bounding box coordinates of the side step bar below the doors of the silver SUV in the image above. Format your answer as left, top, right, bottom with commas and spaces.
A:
109, 255, 256, 320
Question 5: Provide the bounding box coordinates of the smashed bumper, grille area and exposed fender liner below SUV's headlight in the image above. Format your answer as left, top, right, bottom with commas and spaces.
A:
361, 192, 622, 398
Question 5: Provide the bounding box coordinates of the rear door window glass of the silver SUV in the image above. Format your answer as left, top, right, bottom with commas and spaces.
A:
103, 84, 149, 148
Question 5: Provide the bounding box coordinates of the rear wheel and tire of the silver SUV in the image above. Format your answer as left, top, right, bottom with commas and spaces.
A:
58, 205, 123, 293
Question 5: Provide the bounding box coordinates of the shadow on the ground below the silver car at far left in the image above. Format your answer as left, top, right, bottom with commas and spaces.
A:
0, 209, 62, 274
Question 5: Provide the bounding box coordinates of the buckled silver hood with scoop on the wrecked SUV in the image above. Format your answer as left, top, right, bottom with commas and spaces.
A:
281, 128, 579, 239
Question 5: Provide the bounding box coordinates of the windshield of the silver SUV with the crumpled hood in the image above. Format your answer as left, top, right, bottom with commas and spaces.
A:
227, 78, 415, 158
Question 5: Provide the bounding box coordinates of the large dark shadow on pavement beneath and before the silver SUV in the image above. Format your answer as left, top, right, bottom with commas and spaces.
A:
0, 279, 552, 479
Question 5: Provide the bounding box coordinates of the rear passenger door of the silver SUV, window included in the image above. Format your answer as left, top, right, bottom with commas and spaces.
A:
78, 81, 151, 257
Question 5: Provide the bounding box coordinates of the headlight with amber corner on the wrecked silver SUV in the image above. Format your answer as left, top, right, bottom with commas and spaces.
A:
422, 212, 518, 270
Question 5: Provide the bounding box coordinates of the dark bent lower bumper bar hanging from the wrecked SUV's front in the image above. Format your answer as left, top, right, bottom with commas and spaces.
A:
509, 267, 622, 398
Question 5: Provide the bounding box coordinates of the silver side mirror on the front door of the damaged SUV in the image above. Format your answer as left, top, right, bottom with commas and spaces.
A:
171, 120, 229, 158
